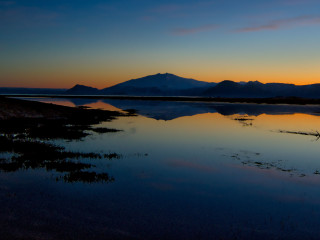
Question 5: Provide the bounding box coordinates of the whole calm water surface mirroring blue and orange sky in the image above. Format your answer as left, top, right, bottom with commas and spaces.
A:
0, 99, 320, 239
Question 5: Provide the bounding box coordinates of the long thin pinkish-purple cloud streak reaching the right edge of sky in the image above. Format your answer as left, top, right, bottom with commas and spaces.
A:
236, 16, 320, 32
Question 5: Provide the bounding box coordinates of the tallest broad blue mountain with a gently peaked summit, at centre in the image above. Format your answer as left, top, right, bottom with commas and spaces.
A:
101, 73, 215, 96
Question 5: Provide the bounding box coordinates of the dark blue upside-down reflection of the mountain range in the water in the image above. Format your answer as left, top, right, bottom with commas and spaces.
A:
70, 99, 320, 120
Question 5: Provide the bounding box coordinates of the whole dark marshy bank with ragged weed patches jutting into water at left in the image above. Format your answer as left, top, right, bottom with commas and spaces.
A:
0, 97, 130, 182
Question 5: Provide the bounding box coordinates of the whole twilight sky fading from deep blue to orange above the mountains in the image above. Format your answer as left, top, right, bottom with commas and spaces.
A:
0, 0, 320, 88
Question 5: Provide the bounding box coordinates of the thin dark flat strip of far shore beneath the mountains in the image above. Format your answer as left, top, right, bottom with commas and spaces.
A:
0, 94, 320, 105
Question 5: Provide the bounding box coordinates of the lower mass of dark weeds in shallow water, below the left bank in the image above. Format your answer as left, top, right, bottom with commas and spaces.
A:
0, 135, 120, 183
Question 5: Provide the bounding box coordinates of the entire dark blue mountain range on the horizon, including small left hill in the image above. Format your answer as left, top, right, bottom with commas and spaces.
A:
65, 73, 320, 99
